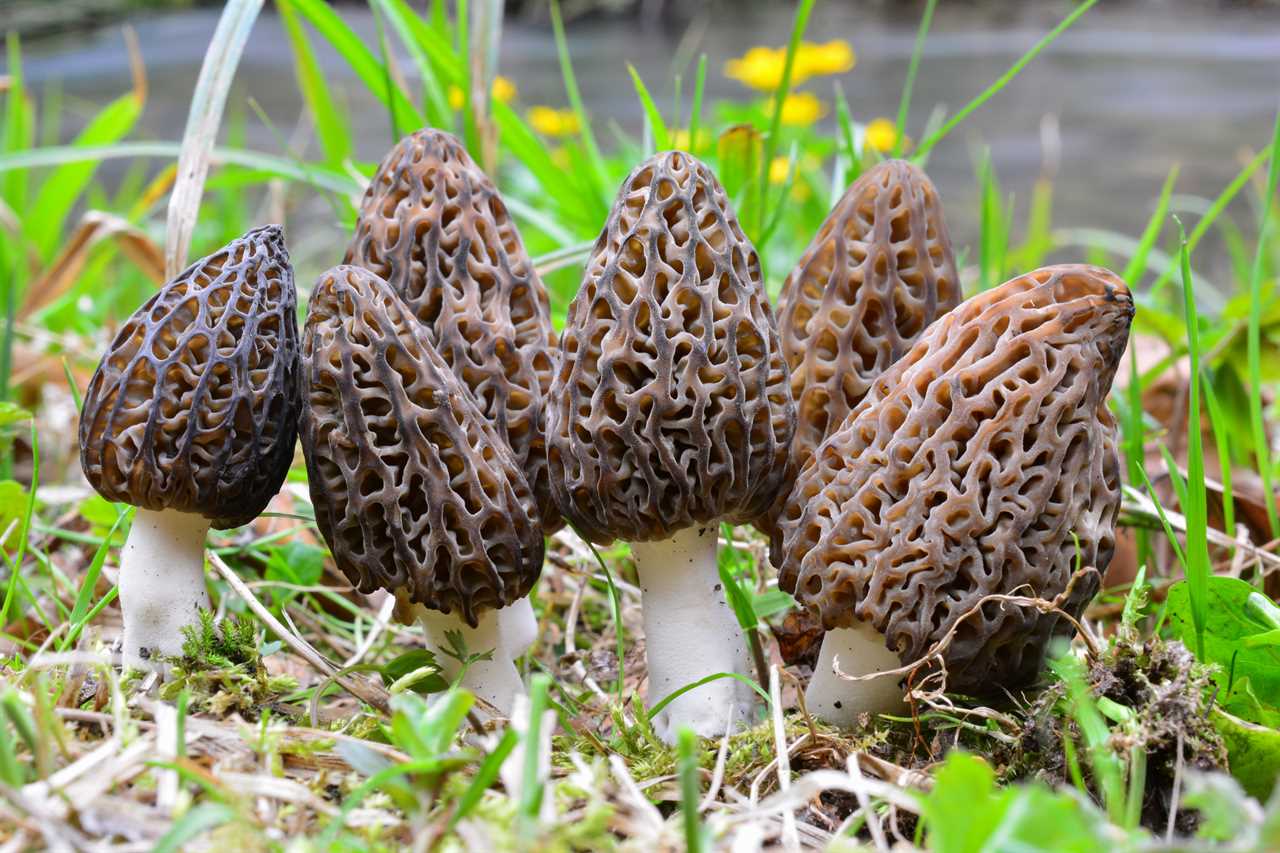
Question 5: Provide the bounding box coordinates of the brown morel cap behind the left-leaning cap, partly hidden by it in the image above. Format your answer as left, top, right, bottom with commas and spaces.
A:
344, 129, 559, 533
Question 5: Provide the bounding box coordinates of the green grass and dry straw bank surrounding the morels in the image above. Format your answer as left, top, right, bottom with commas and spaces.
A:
0, 0, 1280, 850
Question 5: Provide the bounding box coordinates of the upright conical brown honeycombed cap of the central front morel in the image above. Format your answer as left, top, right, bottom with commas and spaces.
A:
548, 151, 795, 543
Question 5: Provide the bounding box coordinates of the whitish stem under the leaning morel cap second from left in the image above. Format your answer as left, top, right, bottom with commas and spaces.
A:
415, 605, 525, 717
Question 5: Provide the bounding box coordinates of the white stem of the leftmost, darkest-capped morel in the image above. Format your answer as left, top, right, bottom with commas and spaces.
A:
119, 507, 209, 671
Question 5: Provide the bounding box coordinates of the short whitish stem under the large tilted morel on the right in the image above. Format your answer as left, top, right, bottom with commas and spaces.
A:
804, 622, 904, 727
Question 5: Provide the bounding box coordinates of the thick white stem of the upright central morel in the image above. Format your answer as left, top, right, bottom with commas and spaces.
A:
631, 525, 754, 743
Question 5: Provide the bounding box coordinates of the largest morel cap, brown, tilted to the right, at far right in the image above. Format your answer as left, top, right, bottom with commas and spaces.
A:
780, 265, 1134, 694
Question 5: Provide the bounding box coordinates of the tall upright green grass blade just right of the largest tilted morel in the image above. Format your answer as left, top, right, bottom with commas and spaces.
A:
1178, 223, 1212, 661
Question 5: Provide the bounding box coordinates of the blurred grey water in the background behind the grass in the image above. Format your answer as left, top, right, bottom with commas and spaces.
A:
15, 0, 1280, 284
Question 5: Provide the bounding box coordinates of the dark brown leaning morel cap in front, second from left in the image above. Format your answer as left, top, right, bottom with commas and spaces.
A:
302, 266, 543, 626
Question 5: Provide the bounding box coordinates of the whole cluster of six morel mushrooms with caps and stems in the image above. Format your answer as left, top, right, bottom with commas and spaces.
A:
79, 129, 1134, 740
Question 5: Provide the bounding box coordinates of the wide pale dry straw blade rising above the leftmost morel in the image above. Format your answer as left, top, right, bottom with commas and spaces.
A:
164, 0, 262, 279
